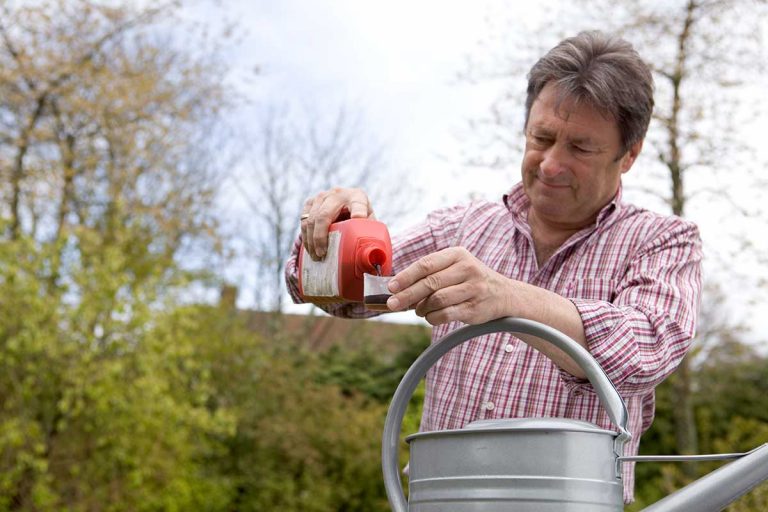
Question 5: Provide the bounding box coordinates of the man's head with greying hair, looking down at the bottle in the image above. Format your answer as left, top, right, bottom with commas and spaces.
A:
522, 32, 653, 231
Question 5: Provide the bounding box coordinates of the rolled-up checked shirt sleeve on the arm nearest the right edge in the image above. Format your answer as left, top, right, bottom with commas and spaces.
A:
564, 218, 702, 396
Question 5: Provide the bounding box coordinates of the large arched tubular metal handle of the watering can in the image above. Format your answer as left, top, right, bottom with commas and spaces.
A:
381, 317, 631, 512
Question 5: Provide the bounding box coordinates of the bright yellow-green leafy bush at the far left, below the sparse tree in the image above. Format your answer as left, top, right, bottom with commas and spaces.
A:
0, 240, 233, 511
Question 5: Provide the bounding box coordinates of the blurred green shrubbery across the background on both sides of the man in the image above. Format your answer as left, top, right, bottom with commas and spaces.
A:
0, 241, 768, 512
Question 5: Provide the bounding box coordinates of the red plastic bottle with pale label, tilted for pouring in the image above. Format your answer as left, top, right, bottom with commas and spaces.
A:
299, 219, 392, 304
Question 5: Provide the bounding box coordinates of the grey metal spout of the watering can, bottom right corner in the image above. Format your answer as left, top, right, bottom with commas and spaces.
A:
643, 444, 768, 512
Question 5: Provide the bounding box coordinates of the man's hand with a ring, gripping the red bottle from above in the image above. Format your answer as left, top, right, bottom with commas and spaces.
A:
301, 188, 376, 261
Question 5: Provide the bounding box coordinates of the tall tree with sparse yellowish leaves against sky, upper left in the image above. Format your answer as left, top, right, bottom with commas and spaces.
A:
0, 0, 227, 294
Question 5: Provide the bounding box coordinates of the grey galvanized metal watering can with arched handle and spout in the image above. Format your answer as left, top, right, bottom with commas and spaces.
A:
382, 318, 768, 512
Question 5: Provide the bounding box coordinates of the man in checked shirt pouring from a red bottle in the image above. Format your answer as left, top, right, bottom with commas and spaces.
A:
286, 32, 701, 501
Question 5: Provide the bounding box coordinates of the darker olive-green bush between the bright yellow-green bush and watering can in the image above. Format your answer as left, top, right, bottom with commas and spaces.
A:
154, 308, 408, 512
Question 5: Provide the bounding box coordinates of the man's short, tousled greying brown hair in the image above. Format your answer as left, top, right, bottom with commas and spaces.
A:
525, 31, 653, 155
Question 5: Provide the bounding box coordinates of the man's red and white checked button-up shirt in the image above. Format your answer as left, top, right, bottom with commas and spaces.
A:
286, 184, 701, 501
